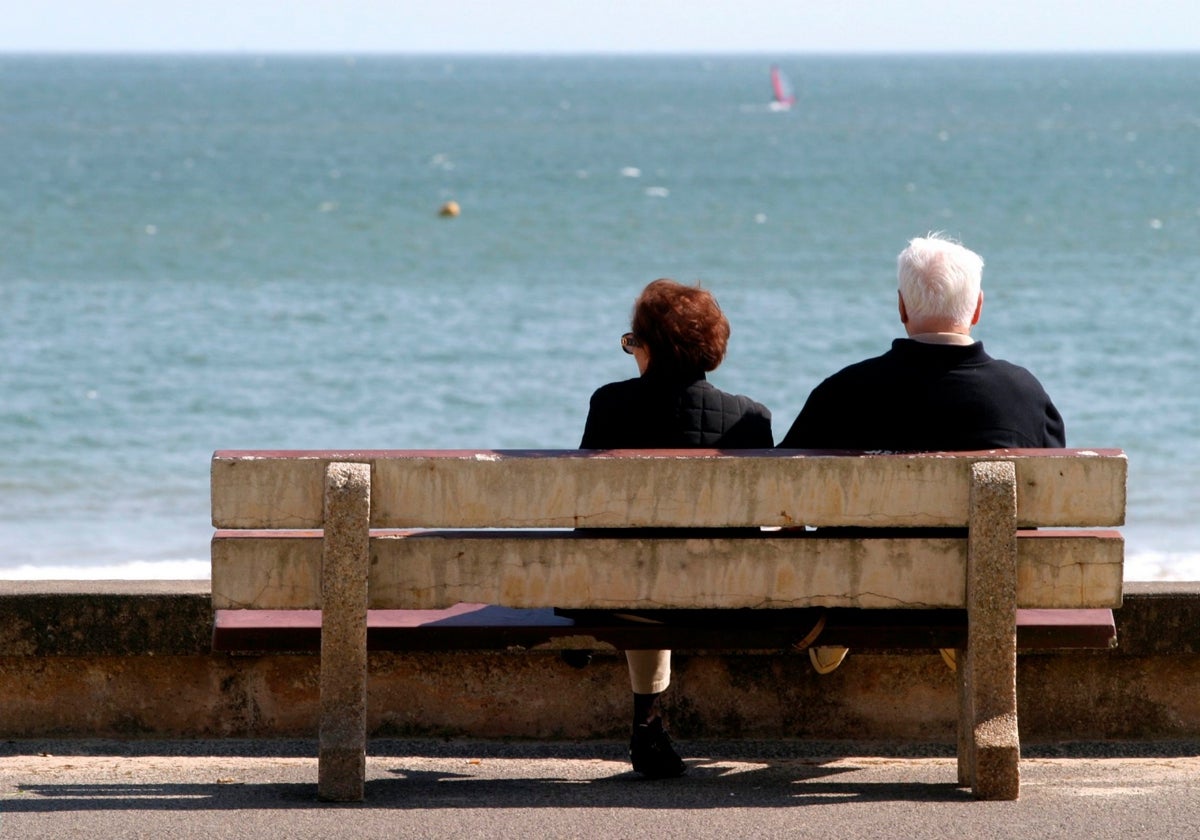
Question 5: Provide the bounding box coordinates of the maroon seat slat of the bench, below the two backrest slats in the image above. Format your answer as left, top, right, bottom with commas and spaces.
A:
212, 604, 1116, 653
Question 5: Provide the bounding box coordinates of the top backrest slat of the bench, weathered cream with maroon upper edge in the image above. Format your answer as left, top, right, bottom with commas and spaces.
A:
211, 449, 1126, 528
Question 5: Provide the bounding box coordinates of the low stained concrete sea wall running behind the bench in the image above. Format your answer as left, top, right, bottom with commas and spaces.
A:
0, 581, 1200, 744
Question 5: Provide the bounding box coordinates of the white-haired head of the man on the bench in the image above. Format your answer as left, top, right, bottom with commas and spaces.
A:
896, 234, 983, 335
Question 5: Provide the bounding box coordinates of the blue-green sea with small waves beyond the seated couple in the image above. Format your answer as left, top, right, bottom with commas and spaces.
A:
0, 54, 1200, 581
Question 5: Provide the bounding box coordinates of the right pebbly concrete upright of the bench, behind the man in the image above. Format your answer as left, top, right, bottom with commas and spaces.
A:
959, 461, 1021, 799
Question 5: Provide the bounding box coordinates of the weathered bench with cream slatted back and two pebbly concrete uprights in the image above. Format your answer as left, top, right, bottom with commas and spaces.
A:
212, 450, 1126, 800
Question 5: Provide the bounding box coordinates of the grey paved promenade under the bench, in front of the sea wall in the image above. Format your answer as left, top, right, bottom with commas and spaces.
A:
0, 740, 1200, 840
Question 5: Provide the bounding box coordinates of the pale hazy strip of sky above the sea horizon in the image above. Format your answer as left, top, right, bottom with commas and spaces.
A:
0, 0, 1200, 54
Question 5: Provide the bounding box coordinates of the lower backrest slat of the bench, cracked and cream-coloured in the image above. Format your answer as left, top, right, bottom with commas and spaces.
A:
212, 530, 1124, 610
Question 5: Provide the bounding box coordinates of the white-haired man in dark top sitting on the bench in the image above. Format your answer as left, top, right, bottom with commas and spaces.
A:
779, 234, 1067, 673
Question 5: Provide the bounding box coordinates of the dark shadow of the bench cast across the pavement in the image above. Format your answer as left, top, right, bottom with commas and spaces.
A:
0, 752, 972, 814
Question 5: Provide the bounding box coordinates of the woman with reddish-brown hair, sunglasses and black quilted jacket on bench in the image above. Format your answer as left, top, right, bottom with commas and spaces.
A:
580, 280, 774, 778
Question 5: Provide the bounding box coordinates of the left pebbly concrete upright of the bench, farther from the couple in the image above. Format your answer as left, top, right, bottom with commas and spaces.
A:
317, 463, 371, 802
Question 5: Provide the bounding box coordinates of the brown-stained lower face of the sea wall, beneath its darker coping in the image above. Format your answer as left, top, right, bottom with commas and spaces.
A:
9, 652, 1200, 744
